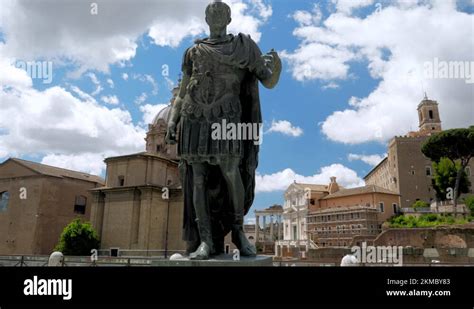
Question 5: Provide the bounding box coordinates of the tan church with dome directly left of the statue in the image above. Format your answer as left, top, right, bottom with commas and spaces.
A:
91, 95, 186, 256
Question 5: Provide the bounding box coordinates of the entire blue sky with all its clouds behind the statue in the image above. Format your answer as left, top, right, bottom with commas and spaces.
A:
0, 0, 474, 221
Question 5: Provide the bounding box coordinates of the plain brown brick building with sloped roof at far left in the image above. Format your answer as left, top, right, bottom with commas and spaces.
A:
0, 158, 104, 255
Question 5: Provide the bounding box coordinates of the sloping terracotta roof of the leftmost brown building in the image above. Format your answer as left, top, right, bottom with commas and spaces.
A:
5, 158, 105, 184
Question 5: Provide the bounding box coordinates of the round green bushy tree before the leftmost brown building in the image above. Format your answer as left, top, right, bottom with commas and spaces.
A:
54, 219, 100, 255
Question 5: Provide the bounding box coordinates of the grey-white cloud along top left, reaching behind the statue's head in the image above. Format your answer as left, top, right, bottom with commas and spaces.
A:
0, 0, 272, 72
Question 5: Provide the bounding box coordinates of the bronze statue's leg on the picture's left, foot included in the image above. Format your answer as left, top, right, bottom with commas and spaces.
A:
189, 163, 214, 260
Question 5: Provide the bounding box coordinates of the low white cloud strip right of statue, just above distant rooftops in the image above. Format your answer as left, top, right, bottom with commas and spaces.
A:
255, 164, 364, 192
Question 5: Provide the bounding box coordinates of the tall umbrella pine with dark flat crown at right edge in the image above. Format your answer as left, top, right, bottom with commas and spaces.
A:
421, 126, 474, 214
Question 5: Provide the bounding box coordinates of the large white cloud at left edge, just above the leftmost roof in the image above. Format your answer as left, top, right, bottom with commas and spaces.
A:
0, 56, 146, 174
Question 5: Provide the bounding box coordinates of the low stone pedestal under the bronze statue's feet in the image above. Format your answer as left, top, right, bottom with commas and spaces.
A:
152, 254, 273, 267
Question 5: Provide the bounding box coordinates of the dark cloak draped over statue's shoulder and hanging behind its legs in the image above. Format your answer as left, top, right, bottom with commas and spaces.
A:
180, 34, 262, 252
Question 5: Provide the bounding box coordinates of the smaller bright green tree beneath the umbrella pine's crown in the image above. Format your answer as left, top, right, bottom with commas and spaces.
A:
431, 158, 471, 201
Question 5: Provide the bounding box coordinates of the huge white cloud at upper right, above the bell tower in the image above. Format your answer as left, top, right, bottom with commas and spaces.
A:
282, 1, 474, 144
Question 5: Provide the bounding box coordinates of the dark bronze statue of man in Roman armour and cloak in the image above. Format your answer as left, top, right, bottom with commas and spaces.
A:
166, 1, 281, 260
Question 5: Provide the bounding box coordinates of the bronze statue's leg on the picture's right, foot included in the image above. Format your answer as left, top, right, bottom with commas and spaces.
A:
220, 159, 257, 256
